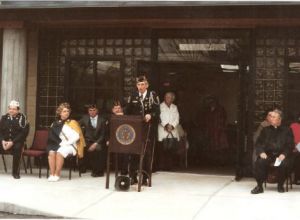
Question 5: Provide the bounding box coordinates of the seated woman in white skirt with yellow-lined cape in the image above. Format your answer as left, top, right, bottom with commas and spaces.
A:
47, 103, 85, 182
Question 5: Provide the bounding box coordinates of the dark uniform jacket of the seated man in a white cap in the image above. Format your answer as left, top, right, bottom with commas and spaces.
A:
0, 113, 29, 143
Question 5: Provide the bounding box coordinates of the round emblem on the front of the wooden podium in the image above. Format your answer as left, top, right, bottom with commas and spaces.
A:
116, 124, 136, 145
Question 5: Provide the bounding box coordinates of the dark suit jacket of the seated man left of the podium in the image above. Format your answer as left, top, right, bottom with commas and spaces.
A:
79, 115, 106, 150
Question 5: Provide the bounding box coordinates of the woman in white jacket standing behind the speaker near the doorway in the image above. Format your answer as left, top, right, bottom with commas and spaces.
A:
158, 92, 179, 170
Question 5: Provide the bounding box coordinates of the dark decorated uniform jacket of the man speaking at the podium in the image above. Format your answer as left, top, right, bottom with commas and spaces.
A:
125, 90, 160, 121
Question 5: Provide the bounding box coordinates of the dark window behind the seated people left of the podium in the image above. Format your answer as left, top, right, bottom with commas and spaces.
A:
65, 58, 123, 118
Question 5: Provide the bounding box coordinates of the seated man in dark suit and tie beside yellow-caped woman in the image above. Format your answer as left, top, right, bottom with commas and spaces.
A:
79, 105, 106, 177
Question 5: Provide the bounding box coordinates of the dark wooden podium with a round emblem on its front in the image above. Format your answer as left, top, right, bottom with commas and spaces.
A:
106, 115, 153, 192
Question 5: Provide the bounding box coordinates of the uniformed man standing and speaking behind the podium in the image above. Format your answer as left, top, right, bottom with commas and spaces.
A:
125, 76, 160, 185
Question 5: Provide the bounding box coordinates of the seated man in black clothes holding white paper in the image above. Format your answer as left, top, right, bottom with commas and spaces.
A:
251, 109, 294, 194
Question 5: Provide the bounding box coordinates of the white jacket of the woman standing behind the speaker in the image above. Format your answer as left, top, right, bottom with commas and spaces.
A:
158, 102, 179, 141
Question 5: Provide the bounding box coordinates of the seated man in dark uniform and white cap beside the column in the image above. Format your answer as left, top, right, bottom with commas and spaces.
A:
0, 100, 29, 179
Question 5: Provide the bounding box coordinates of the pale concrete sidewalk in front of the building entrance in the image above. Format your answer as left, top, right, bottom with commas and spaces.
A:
0, 170, 300, 220
